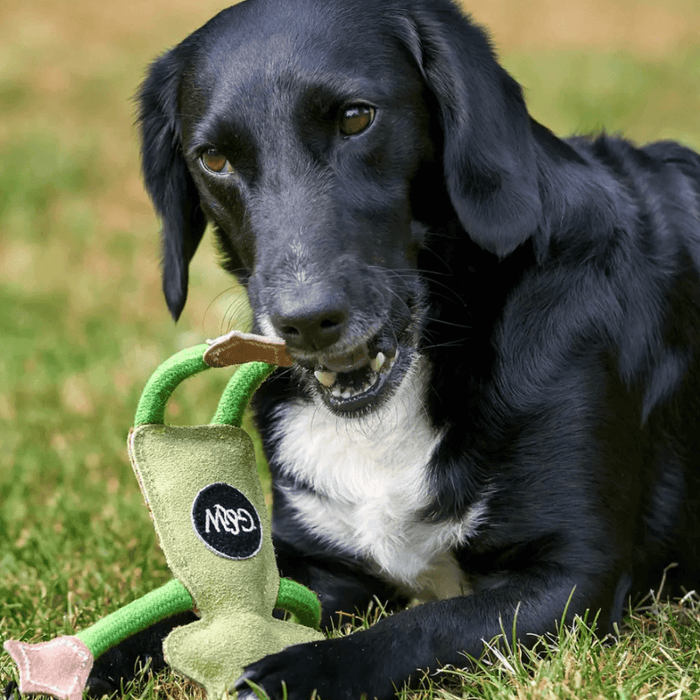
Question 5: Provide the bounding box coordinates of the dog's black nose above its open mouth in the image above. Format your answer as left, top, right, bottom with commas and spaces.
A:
270, 289, 350, 352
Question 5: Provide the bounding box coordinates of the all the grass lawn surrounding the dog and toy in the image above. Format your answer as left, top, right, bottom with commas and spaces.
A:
0, 0, 700, 700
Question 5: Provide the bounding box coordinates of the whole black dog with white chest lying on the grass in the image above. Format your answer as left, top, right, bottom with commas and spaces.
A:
97, 0, 700, 700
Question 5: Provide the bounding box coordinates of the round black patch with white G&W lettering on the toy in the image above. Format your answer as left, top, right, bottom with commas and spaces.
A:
192, 482, 262, 559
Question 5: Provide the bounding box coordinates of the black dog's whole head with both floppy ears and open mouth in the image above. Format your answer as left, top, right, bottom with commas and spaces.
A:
140, 0, 541, 415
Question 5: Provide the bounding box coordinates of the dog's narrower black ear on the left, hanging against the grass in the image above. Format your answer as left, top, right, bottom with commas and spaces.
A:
138, 45, 207, 320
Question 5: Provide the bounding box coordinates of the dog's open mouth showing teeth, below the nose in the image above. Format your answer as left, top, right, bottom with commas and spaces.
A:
298, 343, 410, 415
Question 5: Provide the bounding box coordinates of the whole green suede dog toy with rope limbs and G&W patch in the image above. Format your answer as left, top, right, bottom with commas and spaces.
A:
4, 332, 323, 700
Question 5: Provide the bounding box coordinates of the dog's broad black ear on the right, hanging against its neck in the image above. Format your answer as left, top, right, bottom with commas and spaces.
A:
400, 0, 542, 256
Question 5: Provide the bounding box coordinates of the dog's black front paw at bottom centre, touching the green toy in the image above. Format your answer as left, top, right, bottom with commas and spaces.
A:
235, 635, 395, 700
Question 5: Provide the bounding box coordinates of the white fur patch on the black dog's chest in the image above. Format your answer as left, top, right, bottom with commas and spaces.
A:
278, 360, 486, 600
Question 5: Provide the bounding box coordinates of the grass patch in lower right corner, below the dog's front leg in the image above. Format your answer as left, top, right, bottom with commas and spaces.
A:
402, 596, 700, 700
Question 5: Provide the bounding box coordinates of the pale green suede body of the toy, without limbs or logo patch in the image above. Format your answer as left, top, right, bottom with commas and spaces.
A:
129, 425, 323, 698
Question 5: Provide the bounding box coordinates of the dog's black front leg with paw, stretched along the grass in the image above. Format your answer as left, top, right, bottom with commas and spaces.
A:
237, 567, 607, 700
